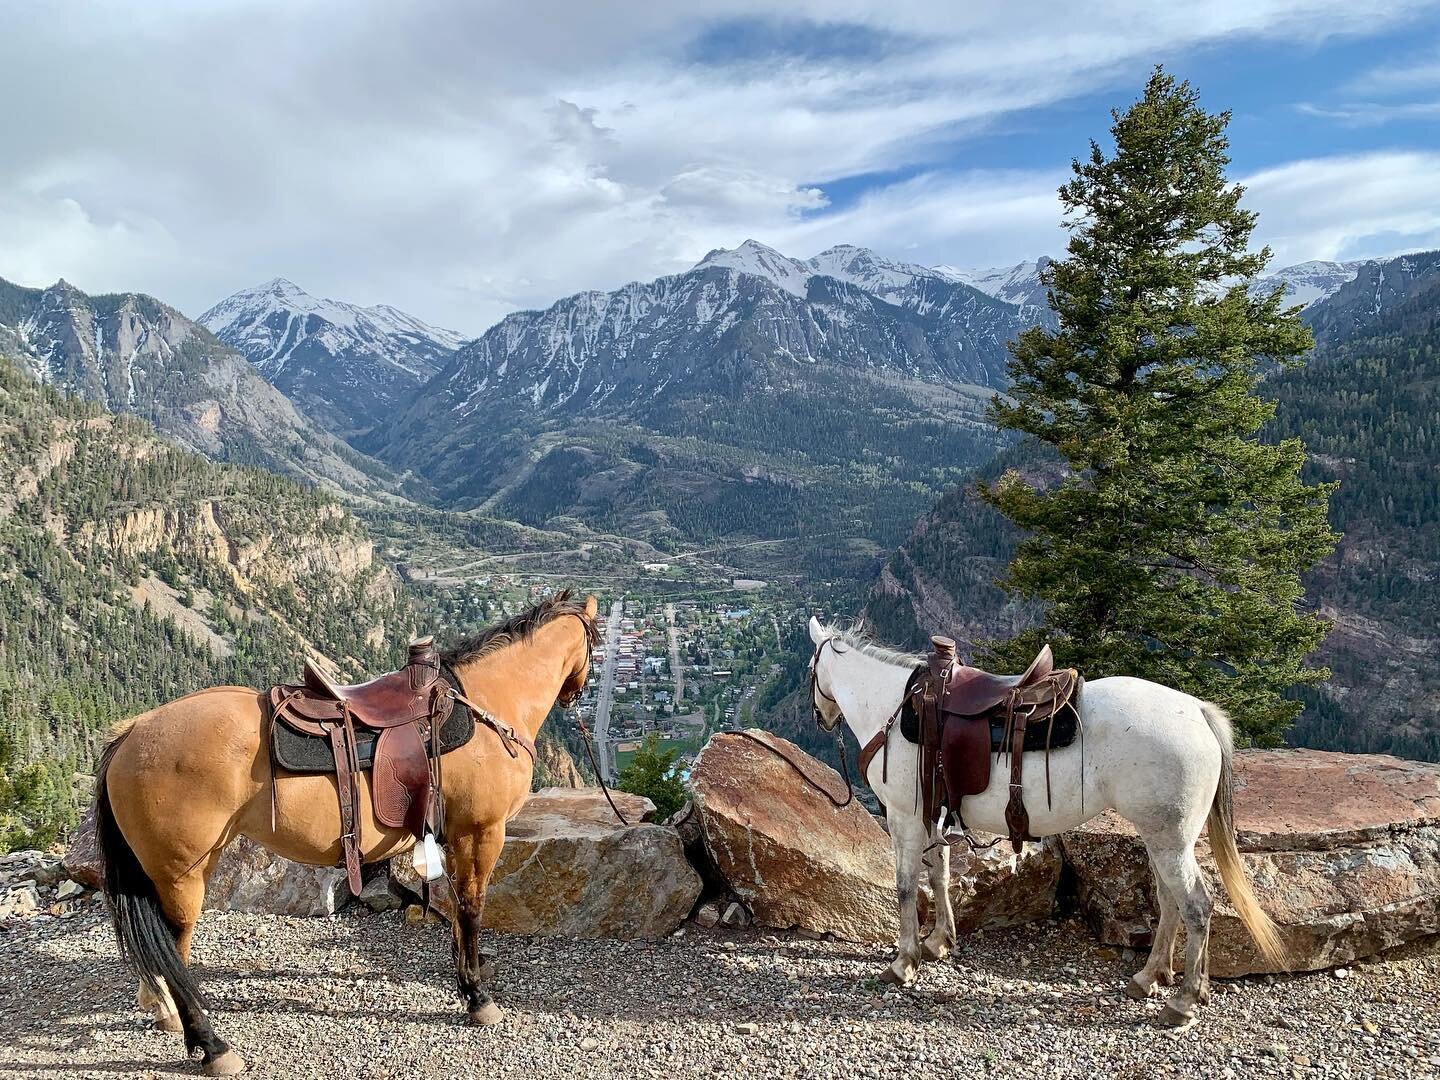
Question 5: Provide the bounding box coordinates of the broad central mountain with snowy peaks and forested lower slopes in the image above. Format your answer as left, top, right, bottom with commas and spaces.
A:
361, 240, 1025, 520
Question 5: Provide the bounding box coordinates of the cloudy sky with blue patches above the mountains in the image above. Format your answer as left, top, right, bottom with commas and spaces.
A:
0, 0, 1440, 333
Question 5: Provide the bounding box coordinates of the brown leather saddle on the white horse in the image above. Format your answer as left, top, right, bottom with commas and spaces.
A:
919, 636, 1083, 851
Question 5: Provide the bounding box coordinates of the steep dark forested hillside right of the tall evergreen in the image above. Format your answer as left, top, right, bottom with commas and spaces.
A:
1274, 279, 1440, 760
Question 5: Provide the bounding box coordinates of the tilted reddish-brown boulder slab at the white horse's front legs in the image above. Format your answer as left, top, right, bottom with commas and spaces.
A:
691, 732, 1061, 942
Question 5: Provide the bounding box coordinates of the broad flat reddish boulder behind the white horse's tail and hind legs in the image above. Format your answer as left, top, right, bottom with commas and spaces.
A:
1064, 750, 1440, 976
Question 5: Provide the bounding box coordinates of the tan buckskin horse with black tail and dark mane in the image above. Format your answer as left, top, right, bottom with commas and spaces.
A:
95, 592, 599, 1076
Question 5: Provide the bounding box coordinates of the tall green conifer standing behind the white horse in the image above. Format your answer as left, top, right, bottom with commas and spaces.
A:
979, 68, 1338, 744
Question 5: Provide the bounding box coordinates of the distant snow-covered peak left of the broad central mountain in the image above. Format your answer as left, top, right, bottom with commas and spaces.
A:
200, 278, 464, 432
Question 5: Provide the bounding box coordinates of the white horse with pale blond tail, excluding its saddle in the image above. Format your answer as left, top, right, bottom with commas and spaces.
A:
809, 618, 1286, 1027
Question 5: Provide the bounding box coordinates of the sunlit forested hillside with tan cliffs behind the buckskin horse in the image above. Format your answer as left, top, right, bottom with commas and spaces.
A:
0, 359, 413, 848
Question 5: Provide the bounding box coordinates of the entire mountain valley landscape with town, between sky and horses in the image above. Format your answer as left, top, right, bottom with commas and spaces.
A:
0, 243, 1440, 852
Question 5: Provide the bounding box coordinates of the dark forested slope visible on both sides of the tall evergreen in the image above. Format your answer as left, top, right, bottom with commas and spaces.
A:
867, 262, 1440, 760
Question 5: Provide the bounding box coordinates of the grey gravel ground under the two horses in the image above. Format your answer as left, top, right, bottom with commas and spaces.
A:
0, 909, 1440, 1080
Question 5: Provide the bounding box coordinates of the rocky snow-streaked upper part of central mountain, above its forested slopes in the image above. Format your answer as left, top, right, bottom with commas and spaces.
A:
377, 240, 1018, 426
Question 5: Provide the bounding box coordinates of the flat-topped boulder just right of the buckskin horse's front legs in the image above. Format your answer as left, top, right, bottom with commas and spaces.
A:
390, 788, 700, 937
